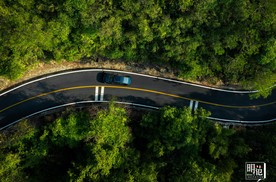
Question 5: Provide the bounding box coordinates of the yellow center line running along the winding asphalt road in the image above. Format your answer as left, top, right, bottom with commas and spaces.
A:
0, 85, 276, 113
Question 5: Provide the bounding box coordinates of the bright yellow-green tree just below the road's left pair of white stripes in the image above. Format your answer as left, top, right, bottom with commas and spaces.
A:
70, 103, 131, 181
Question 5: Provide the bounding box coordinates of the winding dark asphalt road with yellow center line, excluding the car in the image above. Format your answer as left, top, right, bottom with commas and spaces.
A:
0, 69, 276, 129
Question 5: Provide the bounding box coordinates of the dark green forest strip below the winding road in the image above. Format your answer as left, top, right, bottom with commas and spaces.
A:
0, 104, 276, 182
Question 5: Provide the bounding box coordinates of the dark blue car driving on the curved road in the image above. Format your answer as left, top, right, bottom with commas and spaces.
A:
103, 72, 132, 85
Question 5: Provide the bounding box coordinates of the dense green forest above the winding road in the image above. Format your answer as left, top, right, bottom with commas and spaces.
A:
0, 0, 276, 96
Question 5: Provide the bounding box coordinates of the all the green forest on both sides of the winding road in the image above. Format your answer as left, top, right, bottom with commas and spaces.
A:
0, 0, 276, 182
